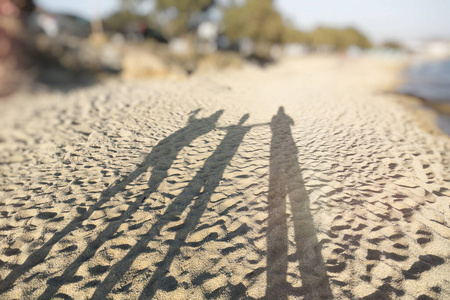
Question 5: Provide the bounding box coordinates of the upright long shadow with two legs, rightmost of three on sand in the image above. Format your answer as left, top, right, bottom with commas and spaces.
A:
266, 107, 332, 299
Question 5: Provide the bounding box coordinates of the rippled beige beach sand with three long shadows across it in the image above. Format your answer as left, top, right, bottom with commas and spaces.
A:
0, 58, 450, 299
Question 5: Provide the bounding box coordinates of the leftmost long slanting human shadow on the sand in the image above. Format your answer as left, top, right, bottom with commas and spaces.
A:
0, 109, 223, 299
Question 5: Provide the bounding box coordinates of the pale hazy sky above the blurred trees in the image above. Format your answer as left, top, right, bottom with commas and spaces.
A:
35, 0, 450, 42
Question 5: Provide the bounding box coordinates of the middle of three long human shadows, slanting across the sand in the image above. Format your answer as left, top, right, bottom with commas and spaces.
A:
92, 114, 252, 299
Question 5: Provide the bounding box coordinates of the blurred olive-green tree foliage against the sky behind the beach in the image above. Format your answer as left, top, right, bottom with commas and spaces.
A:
108, 0, 371, 51
